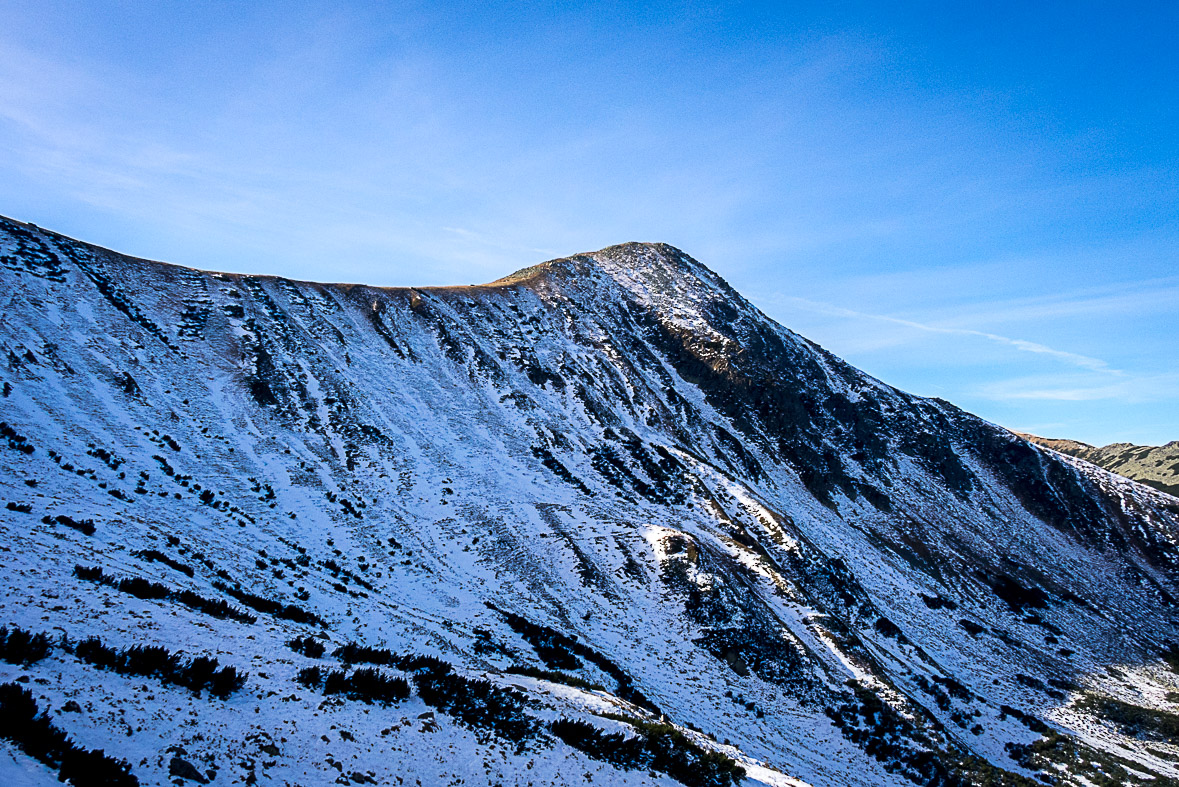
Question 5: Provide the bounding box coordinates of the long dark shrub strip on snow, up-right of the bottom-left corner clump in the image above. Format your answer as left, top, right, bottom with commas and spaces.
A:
73, 636, 248, 700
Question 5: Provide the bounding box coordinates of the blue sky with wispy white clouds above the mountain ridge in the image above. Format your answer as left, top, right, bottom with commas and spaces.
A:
0, 0, 1179, 444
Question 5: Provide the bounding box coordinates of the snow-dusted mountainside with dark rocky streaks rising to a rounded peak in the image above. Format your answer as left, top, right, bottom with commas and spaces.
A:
0, 215, 1179, 787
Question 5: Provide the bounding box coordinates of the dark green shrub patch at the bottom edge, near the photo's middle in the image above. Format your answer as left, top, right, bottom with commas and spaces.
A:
548, 719, 745, 787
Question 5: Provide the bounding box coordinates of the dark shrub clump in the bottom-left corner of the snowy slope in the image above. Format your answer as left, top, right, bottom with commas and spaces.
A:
0, 683, 139, 787
